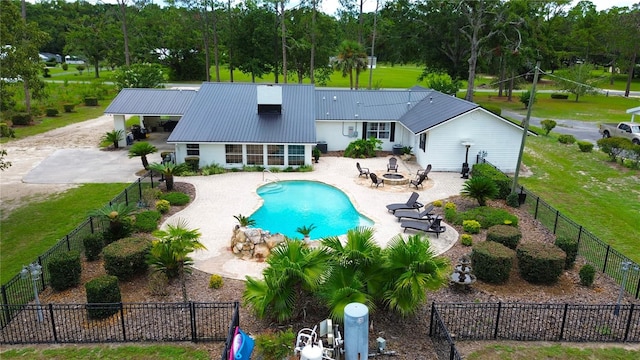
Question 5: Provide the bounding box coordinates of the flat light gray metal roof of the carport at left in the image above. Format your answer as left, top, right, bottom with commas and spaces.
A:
104, 89, 196, 115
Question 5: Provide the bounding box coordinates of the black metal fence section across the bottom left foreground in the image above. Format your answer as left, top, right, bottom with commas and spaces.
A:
0, 302, 240, 344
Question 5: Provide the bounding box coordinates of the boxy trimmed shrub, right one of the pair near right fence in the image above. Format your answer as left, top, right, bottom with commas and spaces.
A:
516, 242, 567, 284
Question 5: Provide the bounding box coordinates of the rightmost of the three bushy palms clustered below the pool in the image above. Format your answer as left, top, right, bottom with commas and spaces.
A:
384, 234, 449, 316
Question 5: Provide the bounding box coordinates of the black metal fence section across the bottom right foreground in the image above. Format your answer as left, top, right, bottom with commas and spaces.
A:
431, 303, 640, 342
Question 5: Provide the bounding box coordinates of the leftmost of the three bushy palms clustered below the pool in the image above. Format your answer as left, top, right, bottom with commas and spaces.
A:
242, 240, 329, 322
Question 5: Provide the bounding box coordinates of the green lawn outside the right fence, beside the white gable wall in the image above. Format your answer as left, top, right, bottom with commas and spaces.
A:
519, 132, 640, 263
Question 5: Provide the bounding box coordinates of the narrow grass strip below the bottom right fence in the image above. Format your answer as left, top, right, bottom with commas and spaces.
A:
465, 345, 640, 360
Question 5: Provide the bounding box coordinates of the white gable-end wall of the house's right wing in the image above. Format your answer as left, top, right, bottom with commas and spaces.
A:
414, 109, 522, 172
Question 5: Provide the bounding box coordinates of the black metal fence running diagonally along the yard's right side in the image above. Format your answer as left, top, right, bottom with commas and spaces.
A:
520, 187, 640, 299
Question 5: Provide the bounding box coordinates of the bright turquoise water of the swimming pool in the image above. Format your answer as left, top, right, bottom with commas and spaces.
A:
250, 181, 373, 239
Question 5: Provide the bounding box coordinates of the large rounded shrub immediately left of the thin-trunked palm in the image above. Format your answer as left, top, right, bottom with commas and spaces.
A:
102, 237, 151, 280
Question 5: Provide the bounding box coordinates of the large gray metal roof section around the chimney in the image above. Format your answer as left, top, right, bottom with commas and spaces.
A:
167, 83, 316, 143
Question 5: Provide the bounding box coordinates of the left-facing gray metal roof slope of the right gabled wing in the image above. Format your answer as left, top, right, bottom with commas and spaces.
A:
398, 90, 479, 134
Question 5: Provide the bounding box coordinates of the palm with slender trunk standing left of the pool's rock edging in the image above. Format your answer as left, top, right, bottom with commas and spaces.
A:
147, 219, 207, 302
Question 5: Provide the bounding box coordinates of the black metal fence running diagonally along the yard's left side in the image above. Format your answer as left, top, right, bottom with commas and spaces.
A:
0, 172, 158, 328
